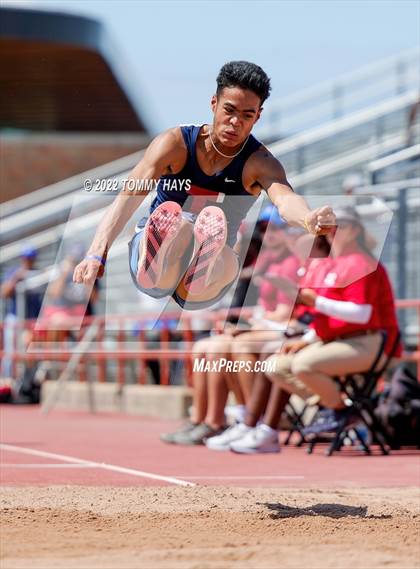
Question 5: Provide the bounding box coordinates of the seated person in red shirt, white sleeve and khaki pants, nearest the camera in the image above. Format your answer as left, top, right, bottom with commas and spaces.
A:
269, 207, 398, 432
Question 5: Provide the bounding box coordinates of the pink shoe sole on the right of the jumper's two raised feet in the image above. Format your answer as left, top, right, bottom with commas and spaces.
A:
183, 206, 227, 294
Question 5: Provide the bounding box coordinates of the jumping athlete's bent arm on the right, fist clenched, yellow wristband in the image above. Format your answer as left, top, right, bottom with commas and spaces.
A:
251, 148, 335, 235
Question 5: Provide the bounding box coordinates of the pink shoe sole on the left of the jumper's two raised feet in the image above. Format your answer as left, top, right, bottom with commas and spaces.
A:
137, 202, 182, 289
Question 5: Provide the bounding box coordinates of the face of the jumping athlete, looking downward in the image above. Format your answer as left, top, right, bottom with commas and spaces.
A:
211, 87, 262, 147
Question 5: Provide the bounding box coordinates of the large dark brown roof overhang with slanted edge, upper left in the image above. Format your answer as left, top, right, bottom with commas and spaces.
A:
0, 7, 153, 132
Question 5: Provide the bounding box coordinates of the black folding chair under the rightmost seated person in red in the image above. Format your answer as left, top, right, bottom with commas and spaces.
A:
308, 330, 400, 456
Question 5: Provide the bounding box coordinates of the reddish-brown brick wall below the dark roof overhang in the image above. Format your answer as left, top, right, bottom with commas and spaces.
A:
0, 133, 148, 202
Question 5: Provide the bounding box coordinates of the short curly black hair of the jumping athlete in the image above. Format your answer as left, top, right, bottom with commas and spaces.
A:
216, 61, 271, 104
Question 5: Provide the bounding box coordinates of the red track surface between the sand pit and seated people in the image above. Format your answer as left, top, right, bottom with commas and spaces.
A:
0, 406, 420, 487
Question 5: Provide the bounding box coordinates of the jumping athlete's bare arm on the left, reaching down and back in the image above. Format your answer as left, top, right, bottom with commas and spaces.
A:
73, 129, 183, 284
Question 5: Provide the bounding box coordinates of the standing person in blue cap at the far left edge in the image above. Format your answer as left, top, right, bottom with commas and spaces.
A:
0, 244, 42, 377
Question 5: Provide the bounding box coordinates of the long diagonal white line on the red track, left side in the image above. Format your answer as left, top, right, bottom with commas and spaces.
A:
0, 444, 195, 486
